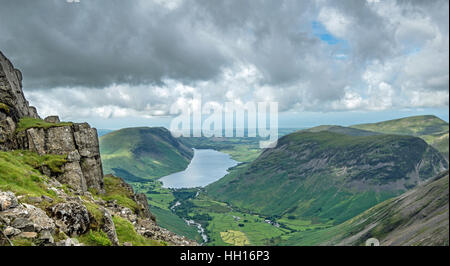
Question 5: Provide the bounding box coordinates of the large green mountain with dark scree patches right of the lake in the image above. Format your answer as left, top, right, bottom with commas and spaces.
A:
206, 131, 448, 224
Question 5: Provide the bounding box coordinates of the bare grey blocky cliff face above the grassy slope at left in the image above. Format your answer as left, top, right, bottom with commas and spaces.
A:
0, 52, 104, 192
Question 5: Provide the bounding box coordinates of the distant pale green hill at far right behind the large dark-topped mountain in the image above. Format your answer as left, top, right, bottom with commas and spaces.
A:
351, 115, 449, 160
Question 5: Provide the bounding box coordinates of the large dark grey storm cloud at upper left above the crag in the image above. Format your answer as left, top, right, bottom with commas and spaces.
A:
0, 0, 228, 88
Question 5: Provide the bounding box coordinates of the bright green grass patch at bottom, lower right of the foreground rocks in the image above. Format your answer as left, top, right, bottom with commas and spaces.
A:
113, 216, 165, 246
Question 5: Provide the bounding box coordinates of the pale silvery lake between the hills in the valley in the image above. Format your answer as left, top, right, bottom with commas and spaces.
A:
159, 149, 238, 188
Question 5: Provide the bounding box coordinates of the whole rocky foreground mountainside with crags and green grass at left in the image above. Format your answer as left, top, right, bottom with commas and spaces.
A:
0, 52, 196, 246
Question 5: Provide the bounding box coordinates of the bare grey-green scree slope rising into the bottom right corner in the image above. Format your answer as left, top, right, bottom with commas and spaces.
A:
284, 171, 449, 246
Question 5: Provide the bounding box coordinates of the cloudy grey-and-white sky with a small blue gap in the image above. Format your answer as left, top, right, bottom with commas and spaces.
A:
0, 0, 449, 129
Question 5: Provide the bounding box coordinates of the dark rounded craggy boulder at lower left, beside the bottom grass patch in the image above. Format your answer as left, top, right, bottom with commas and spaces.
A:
50, 201, 90, 236
